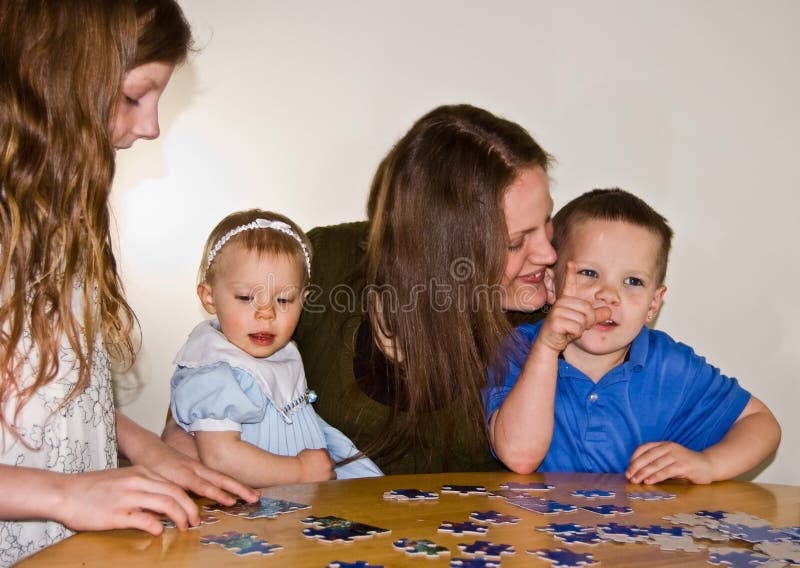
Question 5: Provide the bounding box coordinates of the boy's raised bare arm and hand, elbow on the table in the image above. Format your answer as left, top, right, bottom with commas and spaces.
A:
489, 261, 611, 474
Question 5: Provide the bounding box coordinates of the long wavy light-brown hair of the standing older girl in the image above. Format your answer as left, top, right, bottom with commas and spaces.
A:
0, 0, 191, 431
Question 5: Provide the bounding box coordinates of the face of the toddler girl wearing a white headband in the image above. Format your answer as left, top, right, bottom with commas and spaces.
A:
197, 245, 305, 358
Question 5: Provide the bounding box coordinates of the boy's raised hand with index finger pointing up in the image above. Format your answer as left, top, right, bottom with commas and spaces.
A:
537, 260, 611, 353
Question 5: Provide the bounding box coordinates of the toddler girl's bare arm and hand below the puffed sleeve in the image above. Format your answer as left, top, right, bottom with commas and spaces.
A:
195, 430, 336, 487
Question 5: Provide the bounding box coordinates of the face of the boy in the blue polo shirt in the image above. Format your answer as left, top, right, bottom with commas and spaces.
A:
556, 220, 666, 365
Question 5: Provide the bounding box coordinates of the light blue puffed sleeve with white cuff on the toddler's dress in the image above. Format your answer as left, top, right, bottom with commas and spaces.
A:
170, 363, 267, 432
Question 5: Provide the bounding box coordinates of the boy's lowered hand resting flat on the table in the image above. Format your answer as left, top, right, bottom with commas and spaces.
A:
625, 442, 714, 485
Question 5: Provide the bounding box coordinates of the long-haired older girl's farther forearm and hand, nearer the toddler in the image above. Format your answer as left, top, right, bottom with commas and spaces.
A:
116, 412, 259, 505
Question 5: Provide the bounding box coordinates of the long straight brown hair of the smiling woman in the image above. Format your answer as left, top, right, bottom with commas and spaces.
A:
364, 105, 551, 464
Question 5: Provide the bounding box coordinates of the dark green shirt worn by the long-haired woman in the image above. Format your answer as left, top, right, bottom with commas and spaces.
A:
294, 222, 538, 474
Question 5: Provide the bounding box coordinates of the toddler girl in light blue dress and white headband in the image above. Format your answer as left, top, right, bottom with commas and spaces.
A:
170, 209, 382, 487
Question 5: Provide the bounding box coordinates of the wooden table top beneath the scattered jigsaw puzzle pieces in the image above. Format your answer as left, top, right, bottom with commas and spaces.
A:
20, 473, 800, 568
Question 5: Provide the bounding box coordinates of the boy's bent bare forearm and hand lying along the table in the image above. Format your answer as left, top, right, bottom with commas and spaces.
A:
625, 396, 781, 484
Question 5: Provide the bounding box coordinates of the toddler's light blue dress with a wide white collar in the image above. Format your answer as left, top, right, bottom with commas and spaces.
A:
170, 320, 383, 479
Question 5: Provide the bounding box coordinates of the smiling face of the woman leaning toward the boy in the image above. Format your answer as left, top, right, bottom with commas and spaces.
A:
500, 166, 556, 312
